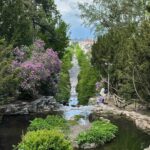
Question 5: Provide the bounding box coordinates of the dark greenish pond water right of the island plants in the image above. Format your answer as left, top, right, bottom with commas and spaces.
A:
97, 117, 150, 150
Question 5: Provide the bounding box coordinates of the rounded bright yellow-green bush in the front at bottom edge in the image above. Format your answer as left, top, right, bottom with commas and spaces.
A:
15, 130, 73, 150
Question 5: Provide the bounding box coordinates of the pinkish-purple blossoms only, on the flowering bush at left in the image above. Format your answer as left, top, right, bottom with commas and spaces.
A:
12, 41, 61, 94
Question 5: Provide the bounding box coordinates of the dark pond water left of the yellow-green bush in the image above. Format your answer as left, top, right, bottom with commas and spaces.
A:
0, 116, 33, 150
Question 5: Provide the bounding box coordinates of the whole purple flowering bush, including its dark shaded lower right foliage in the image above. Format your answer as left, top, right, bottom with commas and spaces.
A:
12, 40, 61, 97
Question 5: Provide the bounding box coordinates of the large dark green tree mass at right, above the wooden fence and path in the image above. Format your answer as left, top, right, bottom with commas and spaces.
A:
92, 21, 150, 101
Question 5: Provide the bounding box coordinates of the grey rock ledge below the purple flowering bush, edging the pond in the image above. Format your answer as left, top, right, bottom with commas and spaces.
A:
0, 96, 59, 115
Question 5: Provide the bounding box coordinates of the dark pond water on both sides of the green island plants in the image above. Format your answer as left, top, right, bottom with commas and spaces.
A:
0, 115, 150, 150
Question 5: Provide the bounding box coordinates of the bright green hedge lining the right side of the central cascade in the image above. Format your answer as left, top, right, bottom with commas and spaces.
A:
76, 46, 99, 105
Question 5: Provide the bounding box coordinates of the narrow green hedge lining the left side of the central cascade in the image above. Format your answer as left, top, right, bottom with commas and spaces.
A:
55, 47, 73, 103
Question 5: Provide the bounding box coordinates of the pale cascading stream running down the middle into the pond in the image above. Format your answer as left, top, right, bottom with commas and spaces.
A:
63, 54, 93, 125
